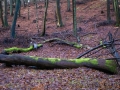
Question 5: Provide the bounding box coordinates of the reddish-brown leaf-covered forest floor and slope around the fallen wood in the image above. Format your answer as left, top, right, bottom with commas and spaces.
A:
0, 0, 120, 90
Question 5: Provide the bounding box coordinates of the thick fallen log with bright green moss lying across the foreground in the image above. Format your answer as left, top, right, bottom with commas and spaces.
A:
0, 54, 117, 73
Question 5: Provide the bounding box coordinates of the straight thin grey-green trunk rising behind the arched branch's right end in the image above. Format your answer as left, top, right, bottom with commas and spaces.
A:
72, 0, 77, 37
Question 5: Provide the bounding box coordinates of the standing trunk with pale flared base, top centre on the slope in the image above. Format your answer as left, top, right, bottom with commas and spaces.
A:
56, 0, 63, 27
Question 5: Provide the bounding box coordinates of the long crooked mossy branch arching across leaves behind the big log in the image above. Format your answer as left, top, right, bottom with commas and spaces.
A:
1, 38, 82, 54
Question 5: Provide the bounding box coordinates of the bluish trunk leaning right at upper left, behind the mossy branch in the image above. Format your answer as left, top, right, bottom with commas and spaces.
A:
11, 0, 20, 38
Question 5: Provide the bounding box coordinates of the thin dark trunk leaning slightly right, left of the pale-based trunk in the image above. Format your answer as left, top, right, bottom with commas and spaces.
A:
41, 0, 49, 36
